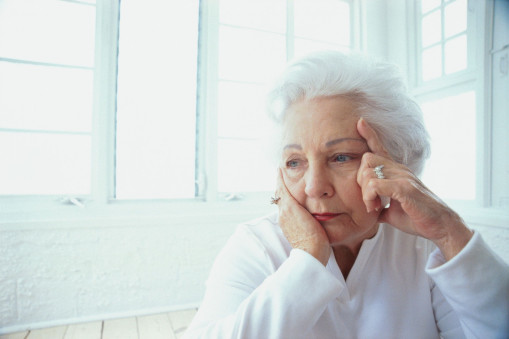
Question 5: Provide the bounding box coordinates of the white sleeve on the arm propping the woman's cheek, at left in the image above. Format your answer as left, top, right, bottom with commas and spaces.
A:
185, 226, 341, 338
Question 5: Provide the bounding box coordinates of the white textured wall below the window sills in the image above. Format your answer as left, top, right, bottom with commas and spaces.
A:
0, 216, 509, 333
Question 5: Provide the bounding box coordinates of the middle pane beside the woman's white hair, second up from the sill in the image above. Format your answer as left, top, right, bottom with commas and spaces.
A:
218, 81, 269, 139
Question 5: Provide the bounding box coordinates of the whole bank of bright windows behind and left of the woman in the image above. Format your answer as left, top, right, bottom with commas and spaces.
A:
0, 0, 353, 212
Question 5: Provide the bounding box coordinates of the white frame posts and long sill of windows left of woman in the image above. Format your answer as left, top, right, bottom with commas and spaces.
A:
0, 0, 359, 230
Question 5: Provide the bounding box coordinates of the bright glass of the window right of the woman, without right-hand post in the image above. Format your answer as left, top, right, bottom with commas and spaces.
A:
414, 0, 483, 203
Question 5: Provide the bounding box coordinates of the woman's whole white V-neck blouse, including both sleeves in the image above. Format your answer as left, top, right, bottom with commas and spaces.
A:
185, 214, 509, 339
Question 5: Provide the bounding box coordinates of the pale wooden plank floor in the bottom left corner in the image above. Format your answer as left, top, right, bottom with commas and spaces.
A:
0, 310, 196, 339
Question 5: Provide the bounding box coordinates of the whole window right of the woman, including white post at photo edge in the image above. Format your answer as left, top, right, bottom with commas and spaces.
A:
413, 0, 508, 222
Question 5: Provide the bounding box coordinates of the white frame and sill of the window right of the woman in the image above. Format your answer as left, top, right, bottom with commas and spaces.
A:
407, 0, 509, 227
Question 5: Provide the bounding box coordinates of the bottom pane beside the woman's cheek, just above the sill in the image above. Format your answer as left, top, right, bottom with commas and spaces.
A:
218, 139, 277, 192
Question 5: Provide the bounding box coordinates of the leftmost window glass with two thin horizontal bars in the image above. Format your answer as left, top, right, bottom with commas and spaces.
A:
0, 0, 95, 195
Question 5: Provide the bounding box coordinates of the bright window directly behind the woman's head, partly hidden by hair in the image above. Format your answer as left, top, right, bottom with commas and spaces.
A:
217, 0, 351, 193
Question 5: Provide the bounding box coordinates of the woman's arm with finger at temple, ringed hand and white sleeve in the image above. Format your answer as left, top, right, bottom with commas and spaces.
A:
357, 119, 509, 338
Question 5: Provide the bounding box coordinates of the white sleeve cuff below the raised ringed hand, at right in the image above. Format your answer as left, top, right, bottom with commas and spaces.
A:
426, 232, 509, 338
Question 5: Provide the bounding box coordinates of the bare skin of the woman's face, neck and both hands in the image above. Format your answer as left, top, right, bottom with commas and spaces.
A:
276, 96, 472, 277
